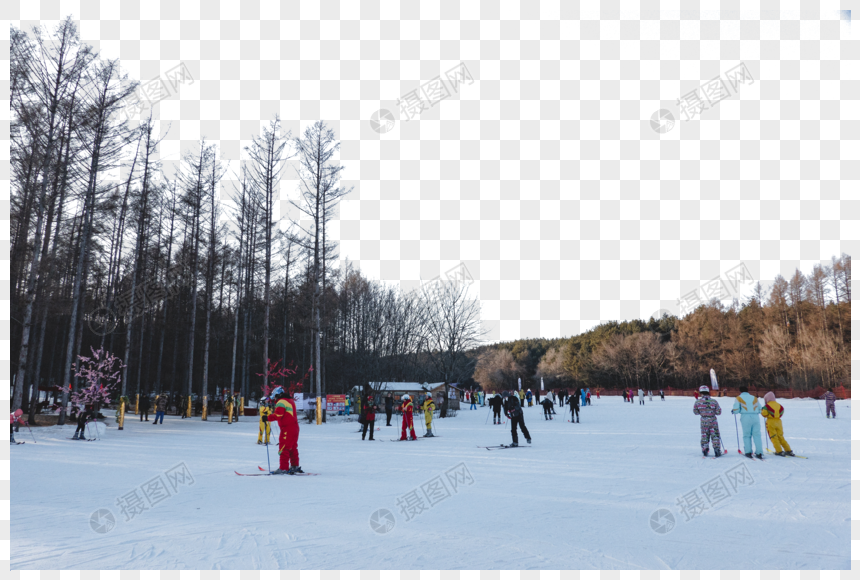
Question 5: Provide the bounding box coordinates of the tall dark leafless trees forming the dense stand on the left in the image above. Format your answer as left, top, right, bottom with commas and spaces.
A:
11, 18, 480, 422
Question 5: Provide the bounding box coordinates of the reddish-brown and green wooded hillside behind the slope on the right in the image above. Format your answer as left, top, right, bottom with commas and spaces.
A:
469, 254, 851, 391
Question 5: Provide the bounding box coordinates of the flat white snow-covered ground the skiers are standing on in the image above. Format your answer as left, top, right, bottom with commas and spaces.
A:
11, 397, 851, 570
